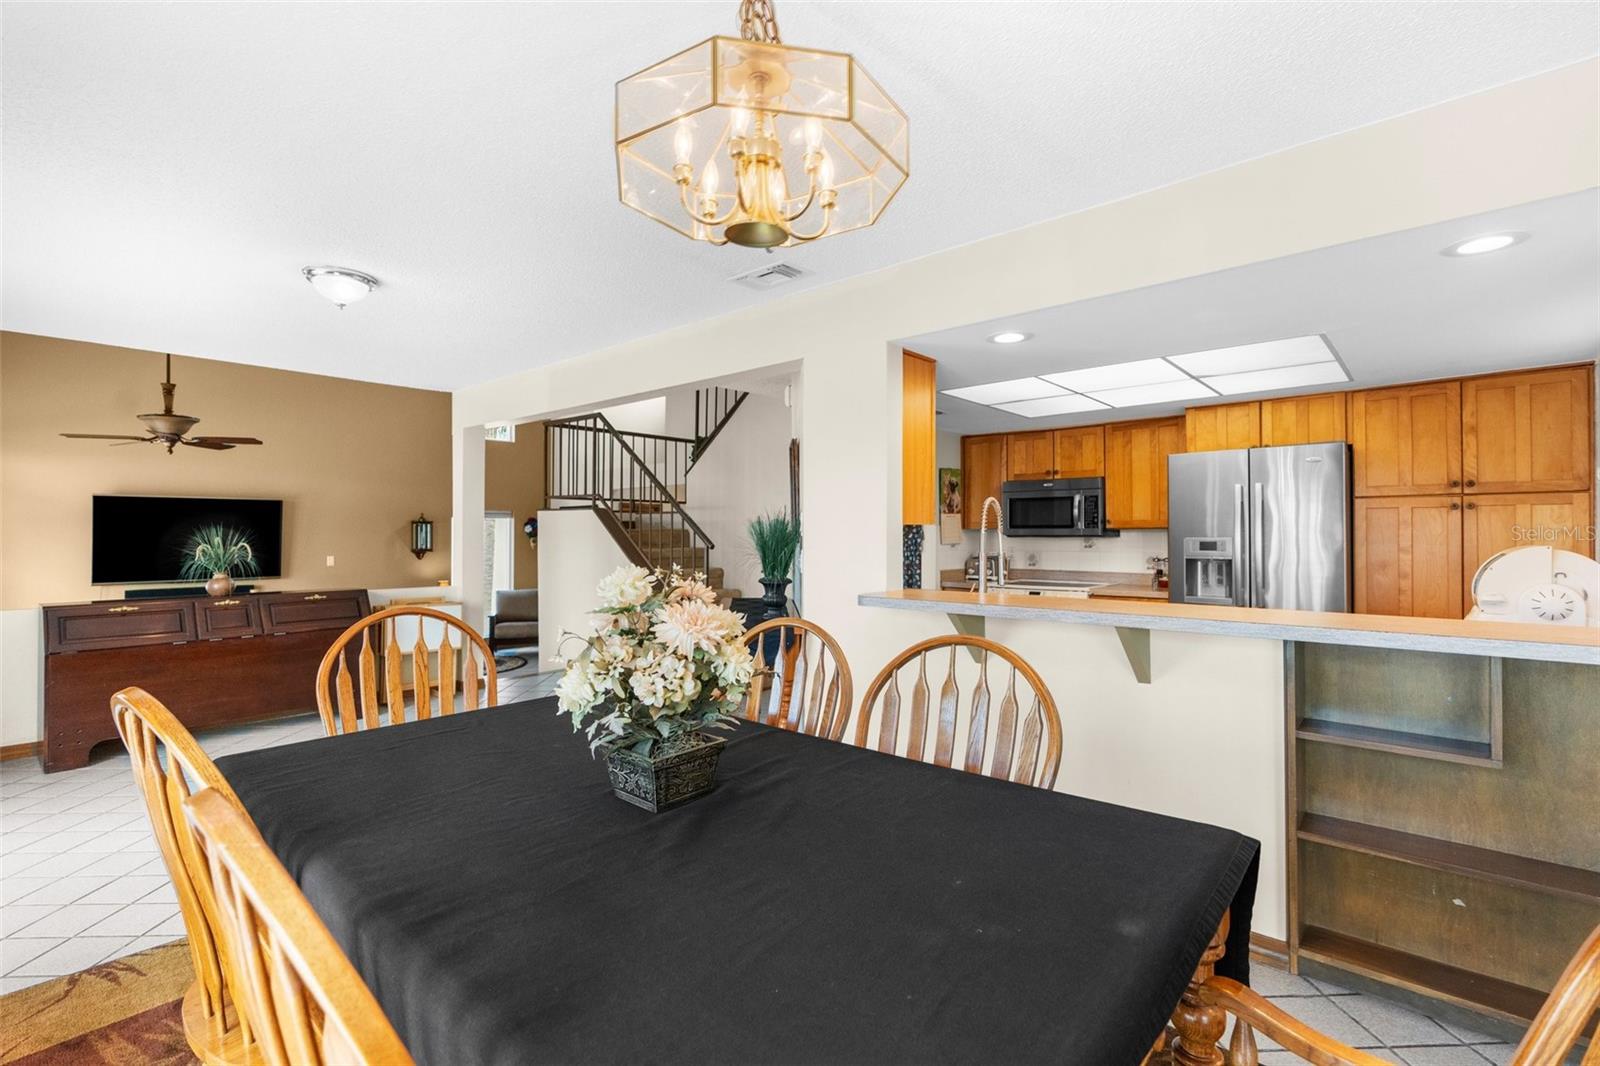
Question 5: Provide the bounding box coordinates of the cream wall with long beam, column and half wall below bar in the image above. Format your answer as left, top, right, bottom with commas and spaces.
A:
454, 61, 1600, 936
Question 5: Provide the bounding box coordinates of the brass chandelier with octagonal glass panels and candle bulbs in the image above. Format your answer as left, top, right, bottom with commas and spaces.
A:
616, 0, 910, 248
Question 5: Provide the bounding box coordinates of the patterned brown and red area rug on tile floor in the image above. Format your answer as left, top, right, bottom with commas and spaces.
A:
0, 940, 198, 1066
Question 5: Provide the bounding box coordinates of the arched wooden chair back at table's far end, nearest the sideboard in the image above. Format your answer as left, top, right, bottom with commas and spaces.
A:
317, 607, 499, 736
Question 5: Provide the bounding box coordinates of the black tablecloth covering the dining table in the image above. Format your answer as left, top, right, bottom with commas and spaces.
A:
219, 699, 1258, 1066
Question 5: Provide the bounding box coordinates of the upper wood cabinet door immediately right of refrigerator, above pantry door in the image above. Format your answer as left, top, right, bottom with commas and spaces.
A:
1350, 381, 1461, 496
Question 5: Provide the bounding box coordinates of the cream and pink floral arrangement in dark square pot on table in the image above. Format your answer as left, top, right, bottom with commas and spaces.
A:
555, 567, 755, 810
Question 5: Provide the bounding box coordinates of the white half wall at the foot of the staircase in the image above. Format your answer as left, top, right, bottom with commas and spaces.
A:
539, 509, 627, 671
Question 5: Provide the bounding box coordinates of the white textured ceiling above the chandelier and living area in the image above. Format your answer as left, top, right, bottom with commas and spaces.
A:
0, 0, 1600, 387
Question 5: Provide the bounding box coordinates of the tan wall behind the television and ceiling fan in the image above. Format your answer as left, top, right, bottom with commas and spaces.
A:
0, 333, 451, 610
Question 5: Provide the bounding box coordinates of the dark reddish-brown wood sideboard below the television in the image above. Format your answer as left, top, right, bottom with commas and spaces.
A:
43, 589, 371, 773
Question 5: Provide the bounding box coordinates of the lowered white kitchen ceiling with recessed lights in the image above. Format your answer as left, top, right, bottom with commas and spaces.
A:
904, 189, 1600, 434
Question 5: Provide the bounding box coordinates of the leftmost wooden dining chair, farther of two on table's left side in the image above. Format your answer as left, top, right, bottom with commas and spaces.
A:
110, 688, 261, 1066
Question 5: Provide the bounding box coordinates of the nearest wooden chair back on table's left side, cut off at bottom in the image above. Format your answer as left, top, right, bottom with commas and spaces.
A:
186, 789, 411, 1066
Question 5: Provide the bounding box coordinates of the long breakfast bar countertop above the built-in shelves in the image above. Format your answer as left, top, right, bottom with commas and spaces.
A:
856, 589, 1600, 666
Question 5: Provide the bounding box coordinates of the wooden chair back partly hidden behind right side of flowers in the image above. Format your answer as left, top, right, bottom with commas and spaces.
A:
742, 618, 853, 739
